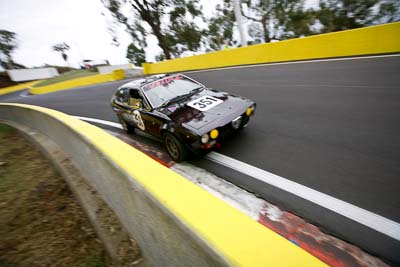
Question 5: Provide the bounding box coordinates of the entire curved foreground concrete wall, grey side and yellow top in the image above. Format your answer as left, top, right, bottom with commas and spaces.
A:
0, 104, 325, 266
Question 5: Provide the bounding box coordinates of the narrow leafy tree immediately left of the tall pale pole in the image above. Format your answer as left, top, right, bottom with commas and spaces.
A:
206, 0, 235, 50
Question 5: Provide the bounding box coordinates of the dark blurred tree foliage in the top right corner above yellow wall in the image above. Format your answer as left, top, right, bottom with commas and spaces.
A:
315, 0, 400, 33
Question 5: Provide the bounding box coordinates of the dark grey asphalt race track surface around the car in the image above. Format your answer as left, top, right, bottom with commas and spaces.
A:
0, 56, 400, 264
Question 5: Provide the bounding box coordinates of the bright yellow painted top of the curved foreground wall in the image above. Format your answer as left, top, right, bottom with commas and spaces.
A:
1, 104, 326, 267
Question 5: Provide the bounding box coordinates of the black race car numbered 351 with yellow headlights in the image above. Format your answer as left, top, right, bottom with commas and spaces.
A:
111, 74, 256, 162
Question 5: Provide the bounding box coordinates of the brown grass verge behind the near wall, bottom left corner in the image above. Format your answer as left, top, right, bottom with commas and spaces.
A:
0, 124, 110, 267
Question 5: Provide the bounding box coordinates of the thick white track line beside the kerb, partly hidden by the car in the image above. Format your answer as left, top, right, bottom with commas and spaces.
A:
74, 116, 400, 241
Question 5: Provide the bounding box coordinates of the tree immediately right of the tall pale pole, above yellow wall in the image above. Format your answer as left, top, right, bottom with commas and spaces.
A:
242, 0, 313, 43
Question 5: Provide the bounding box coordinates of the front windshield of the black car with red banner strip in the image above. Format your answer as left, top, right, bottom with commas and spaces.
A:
142, 75, 204, 108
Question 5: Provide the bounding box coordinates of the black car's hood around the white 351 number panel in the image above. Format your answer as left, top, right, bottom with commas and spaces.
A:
162, 89, 254, 134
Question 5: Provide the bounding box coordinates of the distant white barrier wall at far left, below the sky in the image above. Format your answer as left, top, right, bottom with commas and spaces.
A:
7, 68, 58, 82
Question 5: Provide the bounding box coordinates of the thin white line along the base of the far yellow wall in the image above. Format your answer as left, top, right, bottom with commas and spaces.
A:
182, 54, 400, 73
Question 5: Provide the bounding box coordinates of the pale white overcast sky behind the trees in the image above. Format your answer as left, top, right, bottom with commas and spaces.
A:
0, 0, 316, 67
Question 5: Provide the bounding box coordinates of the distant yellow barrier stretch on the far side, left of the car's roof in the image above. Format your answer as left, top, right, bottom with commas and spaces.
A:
29, 70, 125, 95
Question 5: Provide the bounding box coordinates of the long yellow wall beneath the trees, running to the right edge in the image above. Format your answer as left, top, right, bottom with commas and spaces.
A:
143, 22, 400, 74
